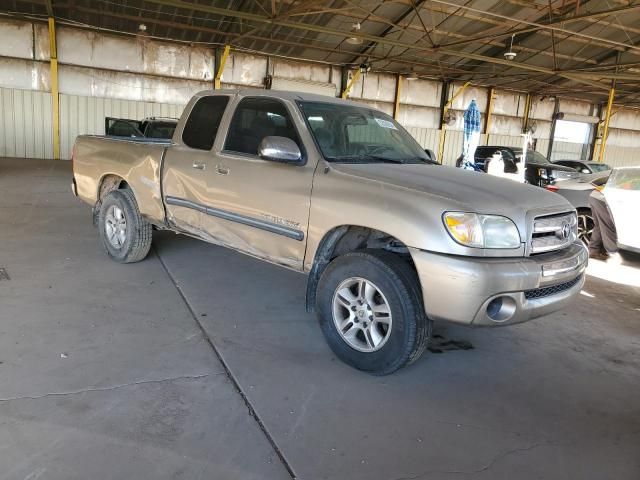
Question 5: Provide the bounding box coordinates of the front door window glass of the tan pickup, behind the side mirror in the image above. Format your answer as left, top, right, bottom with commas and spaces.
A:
224, 98, 302, 155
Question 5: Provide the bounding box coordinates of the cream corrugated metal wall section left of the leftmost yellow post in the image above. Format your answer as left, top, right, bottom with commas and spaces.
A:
0, 88, 53, 158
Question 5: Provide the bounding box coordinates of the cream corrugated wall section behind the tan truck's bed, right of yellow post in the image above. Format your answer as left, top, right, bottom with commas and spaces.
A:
60, 94, 184, 159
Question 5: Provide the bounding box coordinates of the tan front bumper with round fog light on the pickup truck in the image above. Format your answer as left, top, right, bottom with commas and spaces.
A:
410, 242, 588, 326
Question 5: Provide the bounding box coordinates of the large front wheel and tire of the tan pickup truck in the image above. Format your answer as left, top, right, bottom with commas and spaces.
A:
316, 250, 431, 375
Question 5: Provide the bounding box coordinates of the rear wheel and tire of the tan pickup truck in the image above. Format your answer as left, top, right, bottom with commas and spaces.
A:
98, 189, 153, 263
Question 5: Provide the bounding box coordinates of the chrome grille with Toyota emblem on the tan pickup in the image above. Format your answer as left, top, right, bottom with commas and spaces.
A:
531, 212, 578, 254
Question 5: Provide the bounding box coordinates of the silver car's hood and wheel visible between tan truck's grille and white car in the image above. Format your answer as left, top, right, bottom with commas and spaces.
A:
545, 171, 611, 247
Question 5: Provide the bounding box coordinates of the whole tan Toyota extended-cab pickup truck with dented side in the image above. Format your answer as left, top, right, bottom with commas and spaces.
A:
73, 90, 587, 375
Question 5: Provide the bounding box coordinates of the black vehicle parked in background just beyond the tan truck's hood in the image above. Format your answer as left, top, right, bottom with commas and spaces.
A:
456, 146, 580, 187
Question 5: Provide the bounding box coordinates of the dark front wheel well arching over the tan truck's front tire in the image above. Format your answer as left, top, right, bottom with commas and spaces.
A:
306, 225, 415, 312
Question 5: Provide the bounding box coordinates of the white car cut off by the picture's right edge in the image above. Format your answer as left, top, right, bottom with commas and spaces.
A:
603, 167, 640, 249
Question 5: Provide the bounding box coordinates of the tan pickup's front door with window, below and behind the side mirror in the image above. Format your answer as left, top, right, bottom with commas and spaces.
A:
202, 97, 315, 269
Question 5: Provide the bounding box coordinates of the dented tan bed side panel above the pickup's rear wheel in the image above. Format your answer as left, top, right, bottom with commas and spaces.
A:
73, 135, 171, 225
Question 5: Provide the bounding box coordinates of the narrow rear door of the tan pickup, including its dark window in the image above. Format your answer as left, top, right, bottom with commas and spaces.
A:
162, 95, 230, 236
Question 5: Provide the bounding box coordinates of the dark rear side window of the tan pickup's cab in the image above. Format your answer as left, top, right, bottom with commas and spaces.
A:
182, 95, 229, 150
